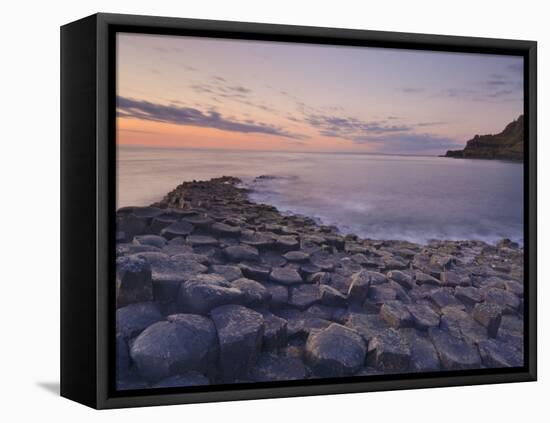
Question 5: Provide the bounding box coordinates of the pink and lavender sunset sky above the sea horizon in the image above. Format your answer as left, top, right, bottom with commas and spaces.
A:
117, 33, 523, 155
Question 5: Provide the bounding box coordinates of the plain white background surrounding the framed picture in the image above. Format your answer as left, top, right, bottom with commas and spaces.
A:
0, 0, 550, 423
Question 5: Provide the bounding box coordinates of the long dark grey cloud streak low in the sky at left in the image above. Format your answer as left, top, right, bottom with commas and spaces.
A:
117, 97, 305, 140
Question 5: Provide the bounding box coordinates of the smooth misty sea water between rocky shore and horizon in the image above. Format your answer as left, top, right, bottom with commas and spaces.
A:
117, 147, 523, 243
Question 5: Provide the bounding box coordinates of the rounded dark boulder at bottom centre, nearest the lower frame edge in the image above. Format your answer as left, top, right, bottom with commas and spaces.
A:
306, 323, 367, 377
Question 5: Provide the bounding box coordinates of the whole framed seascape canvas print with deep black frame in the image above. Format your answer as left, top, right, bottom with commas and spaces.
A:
61, 14, 536, 408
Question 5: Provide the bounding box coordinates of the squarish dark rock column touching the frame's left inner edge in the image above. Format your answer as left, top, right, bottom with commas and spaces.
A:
116, 257, 153, 307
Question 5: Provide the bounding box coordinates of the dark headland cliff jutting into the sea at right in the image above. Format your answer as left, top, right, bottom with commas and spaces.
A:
445, 115, 524, 161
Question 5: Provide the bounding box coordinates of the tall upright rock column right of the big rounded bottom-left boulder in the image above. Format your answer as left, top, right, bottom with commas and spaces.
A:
210, 304, 264, 382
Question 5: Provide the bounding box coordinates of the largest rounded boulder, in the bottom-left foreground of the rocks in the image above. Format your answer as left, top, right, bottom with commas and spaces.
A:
130, 314, 218, 381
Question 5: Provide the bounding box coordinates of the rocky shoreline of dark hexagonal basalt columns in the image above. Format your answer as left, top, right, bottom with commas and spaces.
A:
116, 177, 524, 390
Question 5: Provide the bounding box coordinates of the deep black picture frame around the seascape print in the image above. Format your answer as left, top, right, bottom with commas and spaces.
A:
61, 13, 537, 409
